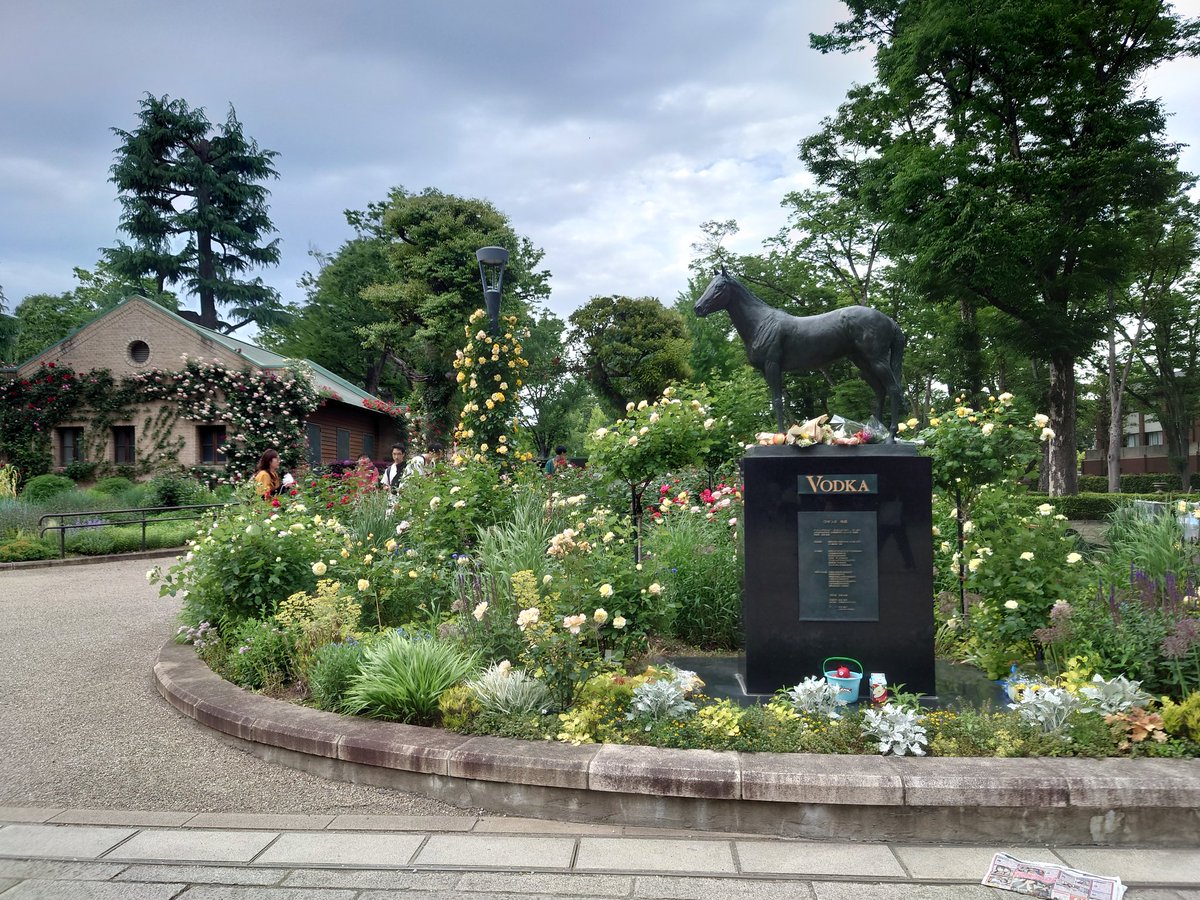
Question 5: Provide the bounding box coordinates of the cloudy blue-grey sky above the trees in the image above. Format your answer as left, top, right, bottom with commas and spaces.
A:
0, 0, 1200, 324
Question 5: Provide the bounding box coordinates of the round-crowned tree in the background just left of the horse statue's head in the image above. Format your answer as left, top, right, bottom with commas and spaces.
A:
568, 296, 691, 414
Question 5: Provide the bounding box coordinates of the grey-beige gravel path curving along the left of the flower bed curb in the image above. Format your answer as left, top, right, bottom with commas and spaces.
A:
0, 559, 478, 815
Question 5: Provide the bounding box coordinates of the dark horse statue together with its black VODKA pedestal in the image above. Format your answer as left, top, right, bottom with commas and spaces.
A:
695, 270, 936, 695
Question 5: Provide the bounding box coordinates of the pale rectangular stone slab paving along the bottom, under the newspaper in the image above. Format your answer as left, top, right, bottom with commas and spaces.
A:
0, 809, 1200, 900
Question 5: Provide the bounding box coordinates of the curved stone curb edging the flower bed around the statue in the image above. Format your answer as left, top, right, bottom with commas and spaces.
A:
154, 642, 1200, 846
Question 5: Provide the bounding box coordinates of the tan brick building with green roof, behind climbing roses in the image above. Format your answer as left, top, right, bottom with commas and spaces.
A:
13, 296, 400, 474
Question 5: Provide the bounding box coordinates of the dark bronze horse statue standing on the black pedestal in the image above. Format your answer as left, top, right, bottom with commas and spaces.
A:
695, 266, 905, 443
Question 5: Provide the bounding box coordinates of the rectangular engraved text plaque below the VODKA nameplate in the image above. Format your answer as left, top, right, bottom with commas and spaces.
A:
797, 510, 880, 622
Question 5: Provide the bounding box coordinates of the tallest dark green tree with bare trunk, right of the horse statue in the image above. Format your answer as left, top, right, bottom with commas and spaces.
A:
802, 0, 1198, 494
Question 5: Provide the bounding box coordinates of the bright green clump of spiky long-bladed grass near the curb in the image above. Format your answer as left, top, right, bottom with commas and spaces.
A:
343, 631, 475, 724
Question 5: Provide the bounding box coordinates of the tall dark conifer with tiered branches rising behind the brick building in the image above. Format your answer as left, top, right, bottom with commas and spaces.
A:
106, 95, 283, 332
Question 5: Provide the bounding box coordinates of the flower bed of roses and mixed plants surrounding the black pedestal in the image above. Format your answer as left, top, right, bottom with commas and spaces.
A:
151, 381, 1200, 756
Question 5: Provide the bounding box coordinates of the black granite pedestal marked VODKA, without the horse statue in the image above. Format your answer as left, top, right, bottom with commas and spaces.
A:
742, 444, 936, 696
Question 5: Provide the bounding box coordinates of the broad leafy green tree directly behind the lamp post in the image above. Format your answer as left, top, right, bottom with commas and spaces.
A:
352, 187, 550, 439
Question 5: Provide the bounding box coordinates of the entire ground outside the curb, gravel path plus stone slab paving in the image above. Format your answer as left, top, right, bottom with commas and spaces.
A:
0, 560, 1200, 900
